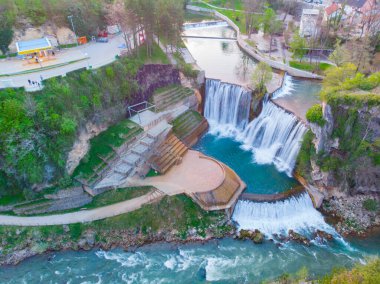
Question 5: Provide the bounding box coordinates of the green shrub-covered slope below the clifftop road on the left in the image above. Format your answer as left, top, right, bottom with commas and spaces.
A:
0, 43, 170, 200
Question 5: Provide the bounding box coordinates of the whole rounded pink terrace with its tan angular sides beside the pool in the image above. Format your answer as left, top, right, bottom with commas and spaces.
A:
133, 150, 246, 211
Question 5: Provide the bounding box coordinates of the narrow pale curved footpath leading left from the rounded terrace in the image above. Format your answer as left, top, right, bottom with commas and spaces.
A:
0, 191, 164, 226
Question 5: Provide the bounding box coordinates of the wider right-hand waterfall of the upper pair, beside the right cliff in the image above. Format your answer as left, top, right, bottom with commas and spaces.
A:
238, 100, 307, 176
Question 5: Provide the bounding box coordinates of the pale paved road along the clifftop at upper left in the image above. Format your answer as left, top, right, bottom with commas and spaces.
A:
0, 35, 125, 88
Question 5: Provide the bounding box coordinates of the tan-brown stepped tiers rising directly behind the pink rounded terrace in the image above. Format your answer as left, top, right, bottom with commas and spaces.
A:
151, 134, 188, 174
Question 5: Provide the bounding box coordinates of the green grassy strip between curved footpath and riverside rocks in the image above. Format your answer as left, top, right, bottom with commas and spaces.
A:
0, 195, 230, 257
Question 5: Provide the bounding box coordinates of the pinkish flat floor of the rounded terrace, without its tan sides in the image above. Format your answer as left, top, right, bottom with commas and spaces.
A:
131, 150, 225, 195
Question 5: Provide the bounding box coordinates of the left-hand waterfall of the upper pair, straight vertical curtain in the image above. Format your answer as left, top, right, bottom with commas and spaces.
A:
204, 79, 251, 136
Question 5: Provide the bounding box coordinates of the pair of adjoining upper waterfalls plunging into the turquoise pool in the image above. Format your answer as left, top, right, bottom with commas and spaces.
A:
204, 76, 307, 176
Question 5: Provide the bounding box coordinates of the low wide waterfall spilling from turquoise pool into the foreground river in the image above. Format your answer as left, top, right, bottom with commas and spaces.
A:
232, 193, 336, 236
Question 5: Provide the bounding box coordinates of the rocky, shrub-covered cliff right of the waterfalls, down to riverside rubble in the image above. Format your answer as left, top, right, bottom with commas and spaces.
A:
296, 95, 380, 234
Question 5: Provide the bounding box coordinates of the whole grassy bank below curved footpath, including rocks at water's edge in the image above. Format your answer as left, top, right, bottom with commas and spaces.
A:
0, 195, 235, 265
